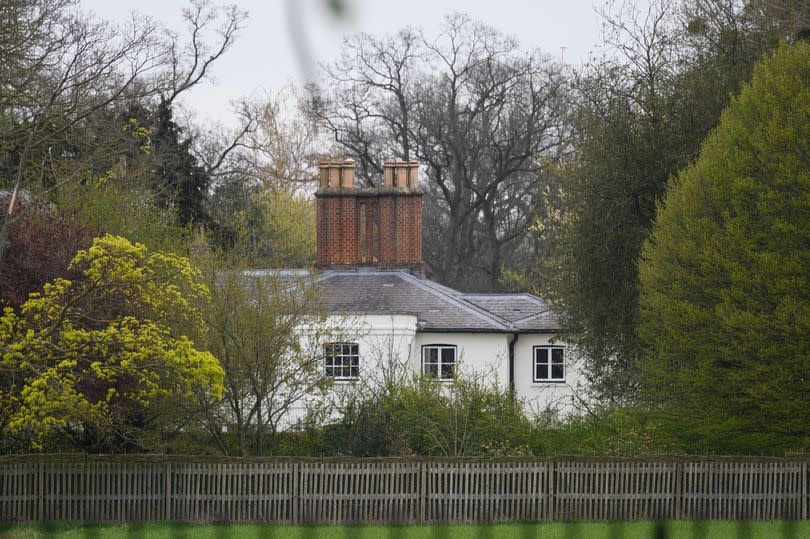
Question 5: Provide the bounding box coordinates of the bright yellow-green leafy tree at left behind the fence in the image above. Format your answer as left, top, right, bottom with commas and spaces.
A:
0, 234, 223, 447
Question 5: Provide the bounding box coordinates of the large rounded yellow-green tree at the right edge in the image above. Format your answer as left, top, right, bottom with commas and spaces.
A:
638, 43, 810, 453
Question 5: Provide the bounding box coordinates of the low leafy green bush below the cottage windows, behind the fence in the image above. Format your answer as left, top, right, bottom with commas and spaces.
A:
323, 376, 537, 457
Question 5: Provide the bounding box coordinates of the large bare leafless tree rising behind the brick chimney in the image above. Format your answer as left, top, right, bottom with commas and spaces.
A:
309, 15, 565, 290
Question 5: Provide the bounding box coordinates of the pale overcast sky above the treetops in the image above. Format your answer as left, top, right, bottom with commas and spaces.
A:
81, 0, 624, 128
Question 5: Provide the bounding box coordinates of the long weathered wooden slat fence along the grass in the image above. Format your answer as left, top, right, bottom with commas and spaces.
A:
0, 455, 810, 524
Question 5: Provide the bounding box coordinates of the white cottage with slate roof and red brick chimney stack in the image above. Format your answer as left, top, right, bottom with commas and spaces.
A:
286, 160, 583, 420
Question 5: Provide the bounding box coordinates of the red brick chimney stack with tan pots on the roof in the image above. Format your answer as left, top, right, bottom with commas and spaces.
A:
315, 159, 424, 273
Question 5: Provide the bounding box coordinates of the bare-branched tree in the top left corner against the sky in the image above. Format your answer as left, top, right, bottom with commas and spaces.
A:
0, 0, 245, 296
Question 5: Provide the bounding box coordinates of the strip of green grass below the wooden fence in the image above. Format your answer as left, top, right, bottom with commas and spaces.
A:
0, 521, 810, 539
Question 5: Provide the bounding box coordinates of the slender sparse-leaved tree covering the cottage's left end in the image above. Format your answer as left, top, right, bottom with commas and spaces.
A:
201, 264, 352, 456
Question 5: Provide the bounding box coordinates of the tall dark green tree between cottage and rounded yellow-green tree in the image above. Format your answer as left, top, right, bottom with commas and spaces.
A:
526, 0, 795, 400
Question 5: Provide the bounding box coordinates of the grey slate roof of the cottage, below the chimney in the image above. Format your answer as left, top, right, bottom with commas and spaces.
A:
316, 268, 560, 333
